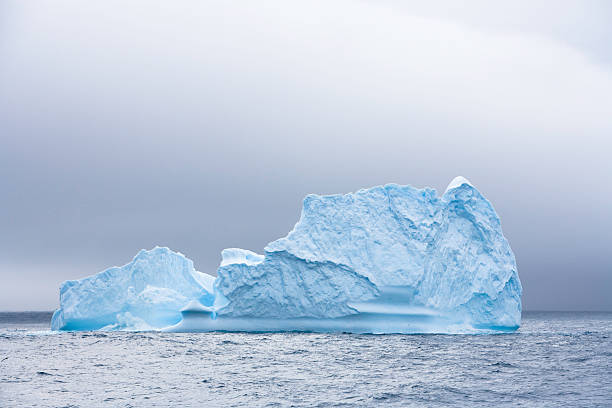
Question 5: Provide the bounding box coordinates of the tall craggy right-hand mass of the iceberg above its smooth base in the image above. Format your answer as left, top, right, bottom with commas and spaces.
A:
215, 178, 521, 327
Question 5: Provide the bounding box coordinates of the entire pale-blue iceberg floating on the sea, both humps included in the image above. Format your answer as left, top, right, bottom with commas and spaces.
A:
52, 177, 522, 333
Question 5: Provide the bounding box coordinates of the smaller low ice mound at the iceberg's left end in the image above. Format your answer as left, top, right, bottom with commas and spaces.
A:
51, 247, 215, 330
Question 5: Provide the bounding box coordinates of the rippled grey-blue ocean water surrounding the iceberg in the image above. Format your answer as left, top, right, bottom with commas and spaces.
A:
0, 312, 612, 407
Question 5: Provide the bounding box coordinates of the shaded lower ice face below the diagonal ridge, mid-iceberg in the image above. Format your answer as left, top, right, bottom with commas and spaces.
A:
215, 250, 378, 319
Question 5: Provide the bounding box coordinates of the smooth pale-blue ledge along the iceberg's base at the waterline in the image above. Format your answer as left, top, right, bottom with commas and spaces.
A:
54, 286, 520, 334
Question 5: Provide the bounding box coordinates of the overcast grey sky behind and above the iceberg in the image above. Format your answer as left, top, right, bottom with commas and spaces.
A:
0, 0, 612, 310
